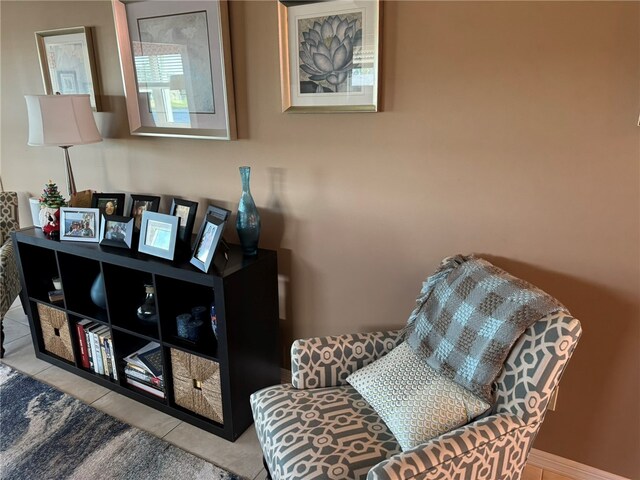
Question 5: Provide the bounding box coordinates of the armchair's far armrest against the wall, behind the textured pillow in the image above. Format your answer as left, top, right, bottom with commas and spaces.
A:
291, 330, 402, 389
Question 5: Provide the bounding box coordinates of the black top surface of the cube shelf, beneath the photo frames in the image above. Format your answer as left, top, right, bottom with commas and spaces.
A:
12, 227, 276, 287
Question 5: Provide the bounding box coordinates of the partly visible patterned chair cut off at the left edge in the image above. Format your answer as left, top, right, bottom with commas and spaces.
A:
0, 192, 21, 358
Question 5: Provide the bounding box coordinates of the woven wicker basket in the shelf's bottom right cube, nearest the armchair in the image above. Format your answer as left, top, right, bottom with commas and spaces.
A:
171, 348, 223, 423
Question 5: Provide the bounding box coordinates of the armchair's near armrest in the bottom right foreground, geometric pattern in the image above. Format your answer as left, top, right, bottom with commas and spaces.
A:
367, 413, 540, 480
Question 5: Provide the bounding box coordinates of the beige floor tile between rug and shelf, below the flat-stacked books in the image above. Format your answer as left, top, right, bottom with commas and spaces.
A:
91, 392, 181, 437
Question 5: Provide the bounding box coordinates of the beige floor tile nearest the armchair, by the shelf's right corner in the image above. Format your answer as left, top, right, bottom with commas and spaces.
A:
164, 422, 264, 479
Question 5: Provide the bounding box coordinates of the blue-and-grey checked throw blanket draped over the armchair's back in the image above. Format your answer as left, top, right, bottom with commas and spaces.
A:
406, 255, 568, 403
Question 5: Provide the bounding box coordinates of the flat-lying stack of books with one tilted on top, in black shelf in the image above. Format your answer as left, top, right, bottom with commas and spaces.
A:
124, 342, 165, 399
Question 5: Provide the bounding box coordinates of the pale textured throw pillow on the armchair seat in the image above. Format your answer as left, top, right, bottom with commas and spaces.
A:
347, 342, 490, 451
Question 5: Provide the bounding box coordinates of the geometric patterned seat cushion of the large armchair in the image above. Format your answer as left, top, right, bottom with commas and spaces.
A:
251, 384, 401, 480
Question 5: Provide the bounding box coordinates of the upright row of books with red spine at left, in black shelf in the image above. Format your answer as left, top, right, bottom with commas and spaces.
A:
76, 319, 118, 381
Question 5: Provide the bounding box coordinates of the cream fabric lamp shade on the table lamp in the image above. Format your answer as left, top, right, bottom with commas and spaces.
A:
24, 95, 102, 147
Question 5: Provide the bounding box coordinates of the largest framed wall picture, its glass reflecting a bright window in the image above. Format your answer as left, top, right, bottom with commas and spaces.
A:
112, 0, 236, 140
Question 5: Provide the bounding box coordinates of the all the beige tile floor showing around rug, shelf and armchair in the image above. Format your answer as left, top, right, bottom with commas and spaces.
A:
2, 301, 572, 480
